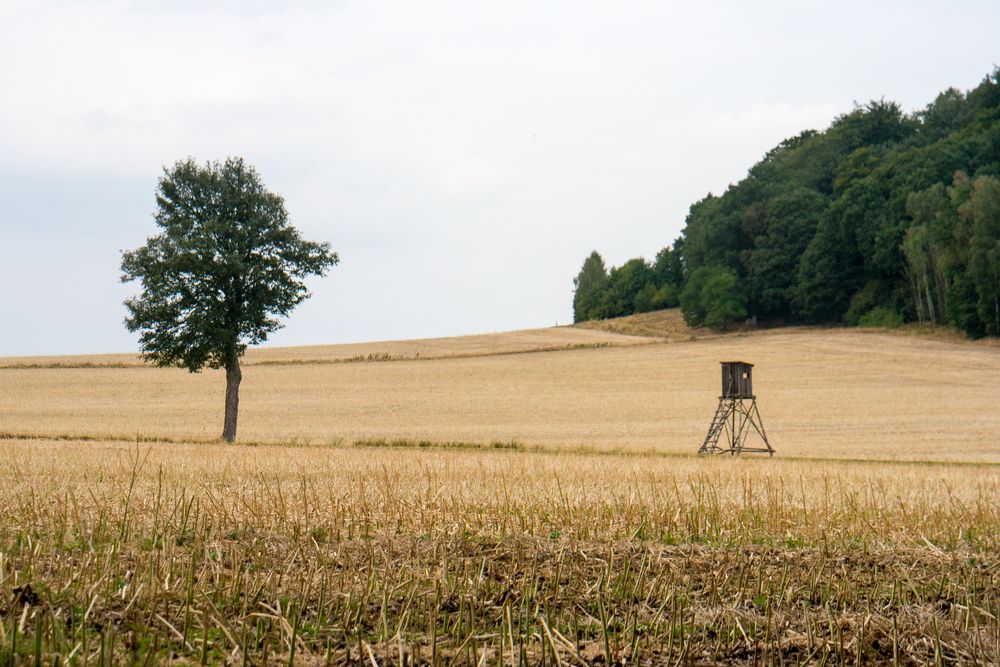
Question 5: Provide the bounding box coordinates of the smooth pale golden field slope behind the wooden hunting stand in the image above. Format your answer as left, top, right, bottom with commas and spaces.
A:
0, 320, 1000, 461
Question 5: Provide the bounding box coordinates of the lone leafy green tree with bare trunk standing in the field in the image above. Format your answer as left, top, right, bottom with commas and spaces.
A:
121, 158, 338, 442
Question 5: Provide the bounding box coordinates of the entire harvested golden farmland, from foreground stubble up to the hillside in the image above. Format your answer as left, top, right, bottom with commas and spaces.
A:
0, 313, 1000, 665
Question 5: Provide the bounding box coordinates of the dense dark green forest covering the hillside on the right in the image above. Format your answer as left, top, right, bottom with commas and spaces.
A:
573, 69, 1000, 337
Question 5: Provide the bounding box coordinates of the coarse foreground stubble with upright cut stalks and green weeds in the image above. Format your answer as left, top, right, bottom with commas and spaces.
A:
0, 440, 1000, 665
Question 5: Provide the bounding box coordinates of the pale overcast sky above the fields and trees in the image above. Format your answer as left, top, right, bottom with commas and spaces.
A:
0, 0, 1000, 356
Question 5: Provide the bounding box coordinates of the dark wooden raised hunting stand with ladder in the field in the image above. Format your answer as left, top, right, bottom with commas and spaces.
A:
698, 361, 774, 455
